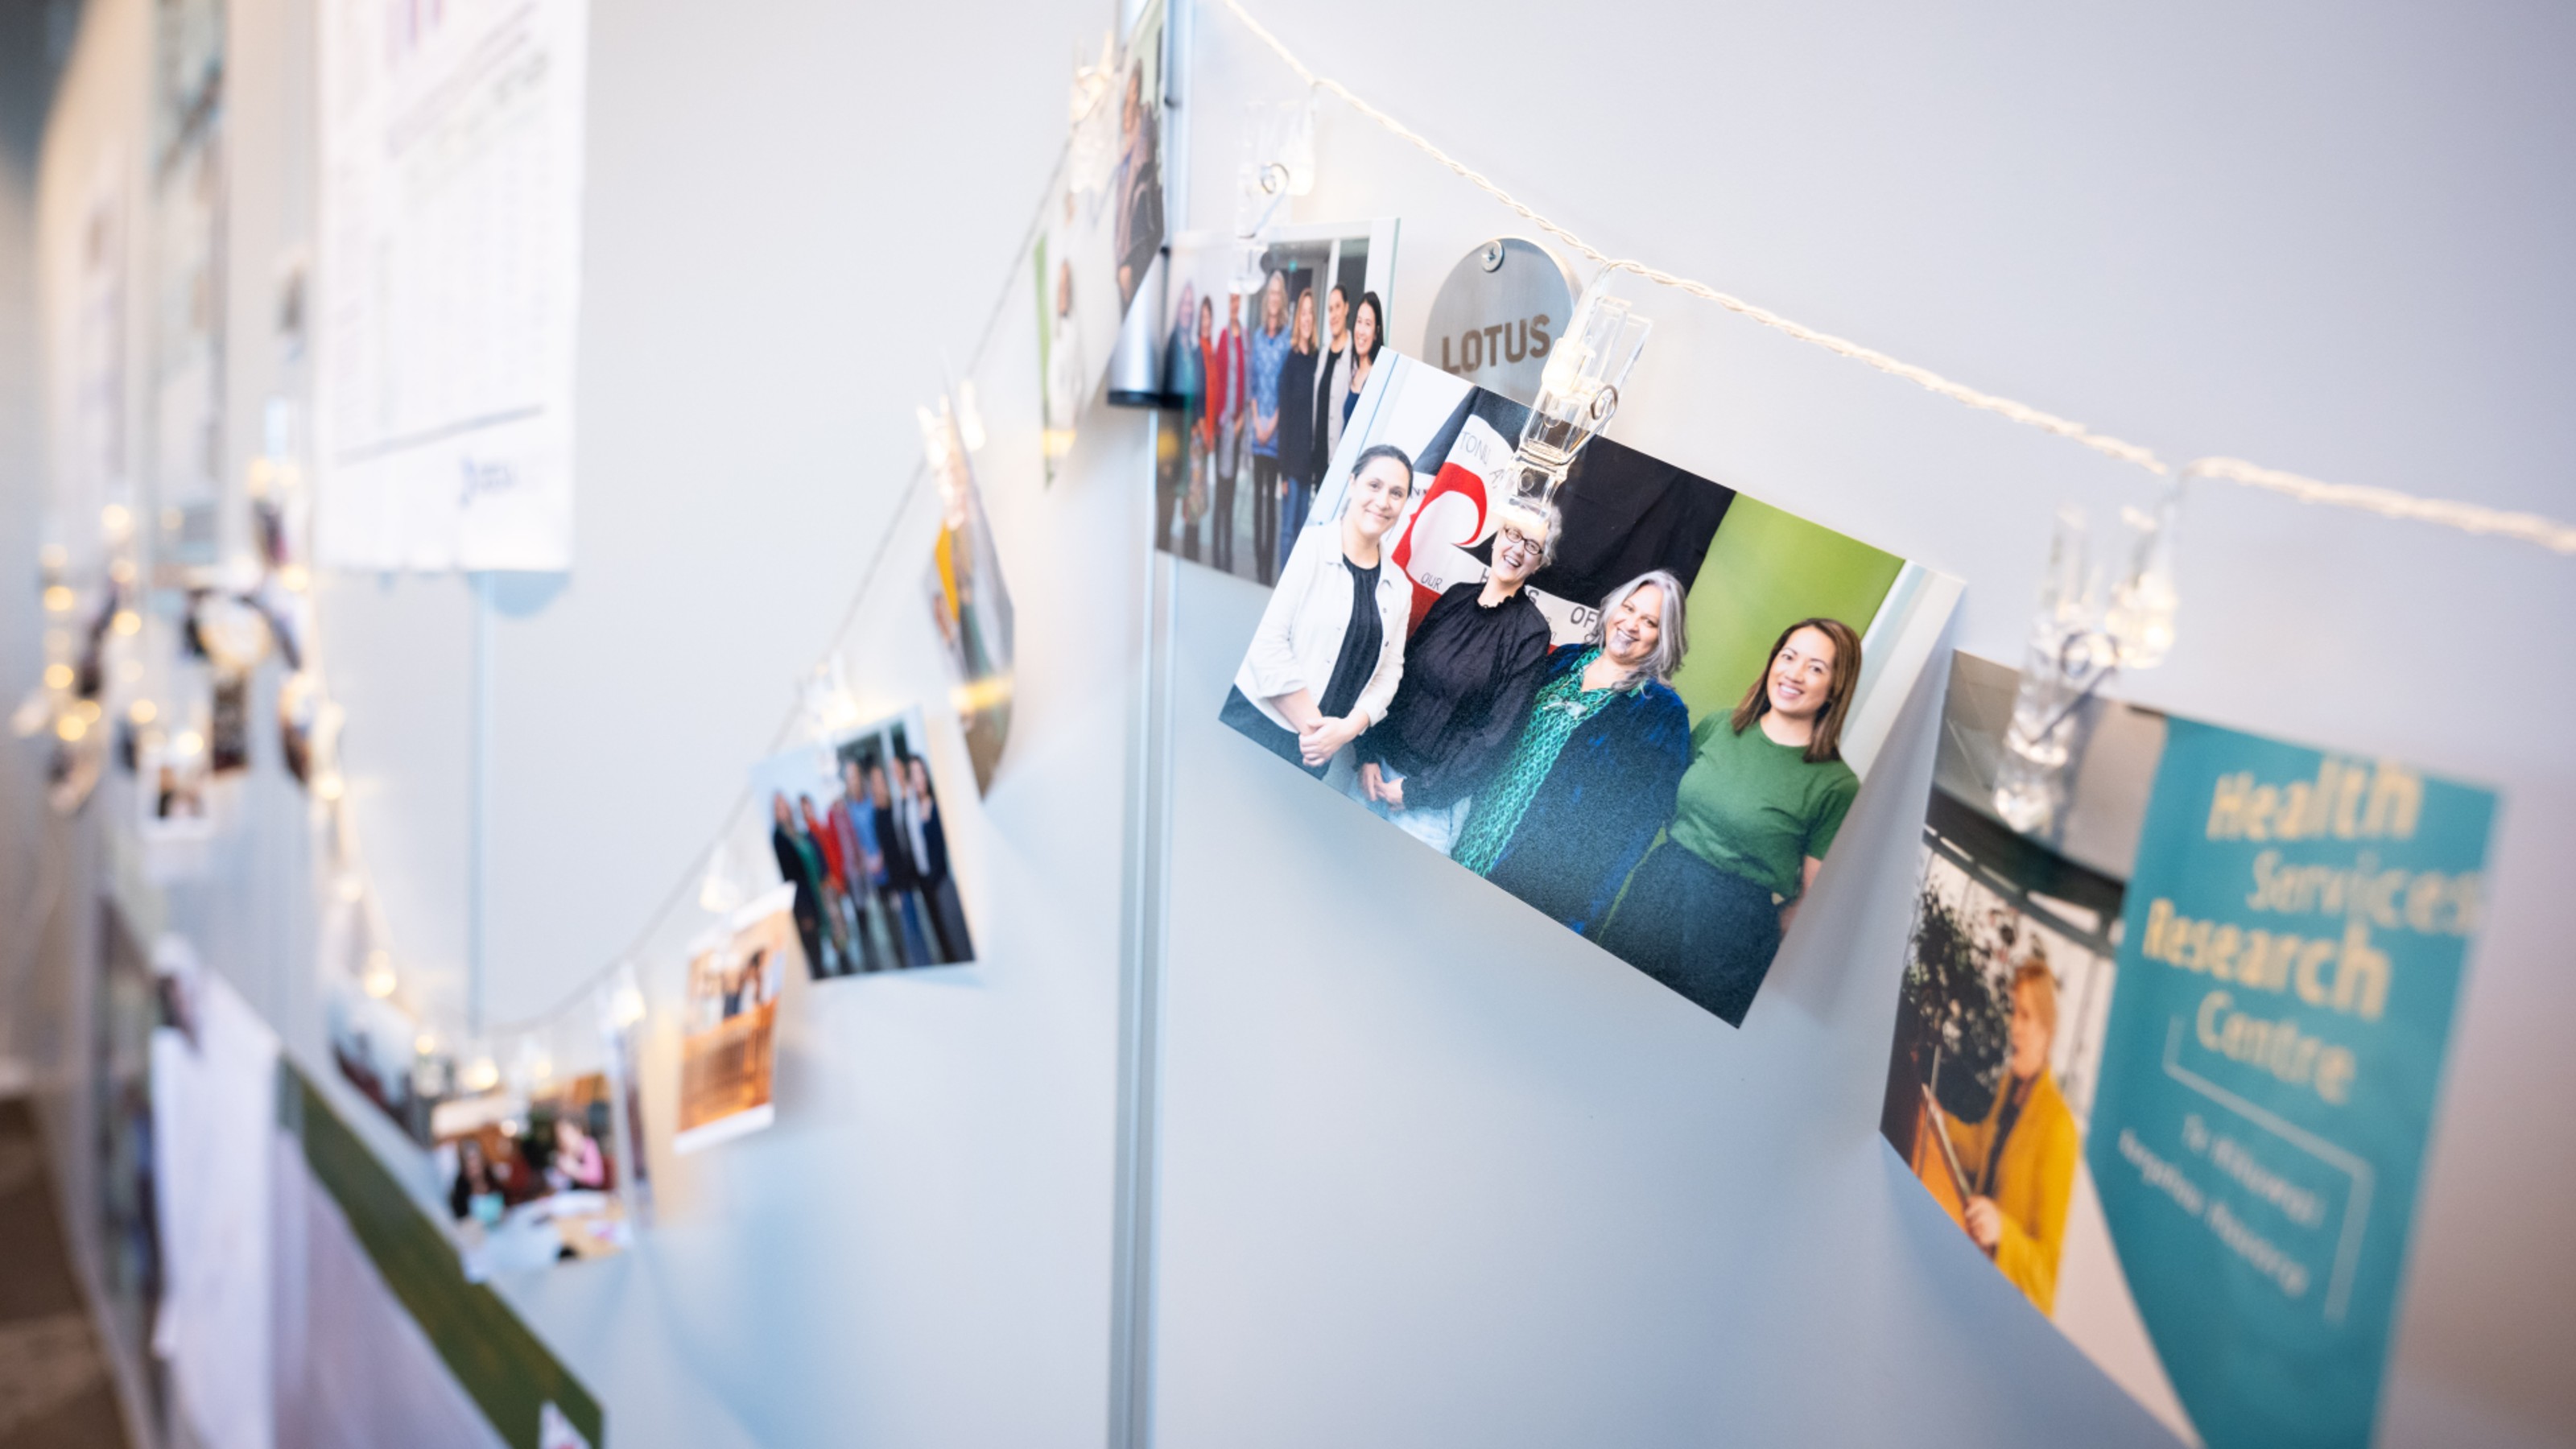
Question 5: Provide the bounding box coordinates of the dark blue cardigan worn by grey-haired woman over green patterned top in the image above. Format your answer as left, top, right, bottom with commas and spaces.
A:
1486, 645, 1690, 936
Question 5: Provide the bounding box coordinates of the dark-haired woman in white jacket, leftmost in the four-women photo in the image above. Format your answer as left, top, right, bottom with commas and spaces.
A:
1224, 444, 1414, 778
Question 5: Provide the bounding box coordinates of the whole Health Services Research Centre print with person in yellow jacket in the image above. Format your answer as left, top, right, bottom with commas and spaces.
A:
1880, 655, 2496, 1449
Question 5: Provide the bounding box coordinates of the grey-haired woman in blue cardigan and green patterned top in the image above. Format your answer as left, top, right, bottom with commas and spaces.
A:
1451, 570, 1690, 936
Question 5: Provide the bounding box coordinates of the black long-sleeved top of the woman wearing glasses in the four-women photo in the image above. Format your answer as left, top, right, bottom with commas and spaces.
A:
1360, 583, 1548, 810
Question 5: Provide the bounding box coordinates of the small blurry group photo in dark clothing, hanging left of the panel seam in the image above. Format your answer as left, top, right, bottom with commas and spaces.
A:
752, 712, 974, 980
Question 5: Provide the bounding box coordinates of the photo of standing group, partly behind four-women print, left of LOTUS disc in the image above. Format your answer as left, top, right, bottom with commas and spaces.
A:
1154, 219, 1396, 588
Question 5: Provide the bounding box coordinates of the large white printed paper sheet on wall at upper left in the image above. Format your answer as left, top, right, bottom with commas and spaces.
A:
314, 0, 590, 570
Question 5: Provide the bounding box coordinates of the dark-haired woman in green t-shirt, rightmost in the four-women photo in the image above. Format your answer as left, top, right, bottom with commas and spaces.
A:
1602, 619, 1860, 1026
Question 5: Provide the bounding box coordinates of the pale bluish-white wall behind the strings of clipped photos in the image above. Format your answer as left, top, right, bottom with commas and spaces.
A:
20, 0, 2576, 1447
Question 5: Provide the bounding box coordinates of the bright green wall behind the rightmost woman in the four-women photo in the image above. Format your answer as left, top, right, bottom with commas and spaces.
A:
1672, 493, 1904, 722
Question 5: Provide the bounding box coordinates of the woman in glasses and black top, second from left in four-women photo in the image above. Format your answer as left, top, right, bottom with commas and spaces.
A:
1350, 508, 1558, 856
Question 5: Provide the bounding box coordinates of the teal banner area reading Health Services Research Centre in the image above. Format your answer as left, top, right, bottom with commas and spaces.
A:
2084, 720, 2496, 1449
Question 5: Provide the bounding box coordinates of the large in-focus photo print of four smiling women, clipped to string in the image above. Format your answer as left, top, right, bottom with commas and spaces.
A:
1221, 348, 1958, 1026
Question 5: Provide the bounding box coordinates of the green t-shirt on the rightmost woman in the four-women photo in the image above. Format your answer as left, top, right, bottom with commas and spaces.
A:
1672, 712, 1860, 900
